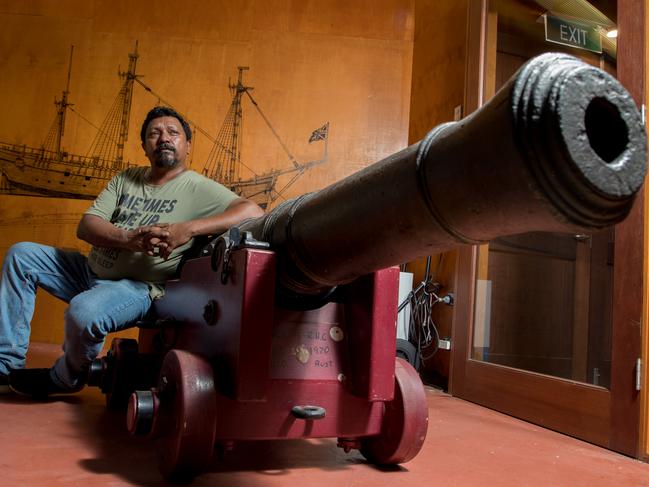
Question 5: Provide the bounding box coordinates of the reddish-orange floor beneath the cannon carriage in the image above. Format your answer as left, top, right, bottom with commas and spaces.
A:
0, 344, 649, 487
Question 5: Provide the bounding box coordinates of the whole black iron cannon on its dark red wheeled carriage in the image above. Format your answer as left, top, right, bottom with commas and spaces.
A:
86, 53, 647, 478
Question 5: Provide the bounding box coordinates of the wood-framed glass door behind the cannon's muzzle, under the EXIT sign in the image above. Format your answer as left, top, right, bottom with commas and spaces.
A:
450, 0, 644, 456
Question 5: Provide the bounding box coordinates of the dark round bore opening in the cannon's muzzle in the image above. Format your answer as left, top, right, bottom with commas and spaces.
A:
584, 97, 629, 163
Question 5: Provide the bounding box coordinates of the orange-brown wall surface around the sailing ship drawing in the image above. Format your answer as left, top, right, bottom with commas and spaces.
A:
0, 0, 414, 342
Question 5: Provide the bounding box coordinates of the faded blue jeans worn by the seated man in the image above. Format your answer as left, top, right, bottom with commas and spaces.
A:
0, 242, 151, 389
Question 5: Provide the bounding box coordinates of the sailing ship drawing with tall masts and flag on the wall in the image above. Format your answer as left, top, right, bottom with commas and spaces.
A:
0, 42, 329, 208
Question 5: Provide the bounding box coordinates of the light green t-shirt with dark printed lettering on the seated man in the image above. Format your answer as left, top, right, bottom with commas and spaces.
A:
86, 167, 237, 298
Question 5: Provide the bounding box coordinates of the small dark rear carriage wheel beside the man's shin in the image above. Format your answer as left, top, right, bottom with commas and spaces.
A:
102, 338, 139, 409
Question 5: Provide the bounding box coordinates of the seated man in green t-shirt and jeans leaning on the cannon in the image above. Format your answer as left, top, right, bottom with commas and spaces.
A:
0, 107, 263, 397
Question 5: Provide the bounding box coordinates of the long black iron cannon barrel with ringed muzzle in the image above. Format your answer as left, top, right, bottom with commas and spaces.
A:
241, 53, 647, 296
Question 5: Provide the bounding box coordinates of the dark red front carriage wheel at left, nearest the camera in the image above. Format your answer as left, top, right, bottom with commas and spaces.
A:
155, 350, 216, 478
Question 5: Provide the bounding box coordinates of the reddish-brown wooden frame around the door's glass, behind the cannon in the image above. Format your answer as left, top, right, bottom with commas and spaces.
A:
449, 0, 645, 457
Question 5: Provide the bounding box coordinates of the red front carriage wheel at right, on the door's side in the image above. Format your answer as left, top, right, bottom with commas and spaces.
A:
360, 358, 428, 465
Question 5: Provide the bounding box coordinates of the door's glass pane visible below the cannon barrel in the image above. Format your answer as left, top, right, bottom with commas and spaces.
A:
471, 229, 614, 388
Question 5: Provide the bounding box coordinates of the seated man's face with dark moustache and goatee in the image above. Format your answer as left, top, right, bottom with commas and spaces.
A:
142, 117, 191, 168
